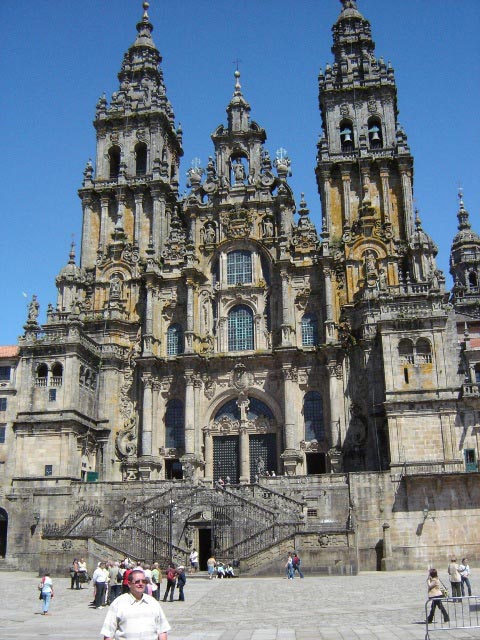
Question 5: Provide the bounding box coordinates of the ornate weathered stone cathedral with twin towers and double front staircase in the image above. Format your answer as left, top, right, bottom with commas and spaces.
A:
0, 0, 480, 575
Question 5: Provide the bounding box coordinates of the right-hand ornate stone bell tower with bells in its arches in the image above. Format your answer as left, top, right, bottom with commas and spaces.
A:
316, 0, 434, 330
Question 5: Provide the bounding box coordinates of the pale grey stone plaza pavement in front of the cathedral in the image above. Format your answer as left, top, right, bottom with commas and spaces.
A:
0, 571, 480, 640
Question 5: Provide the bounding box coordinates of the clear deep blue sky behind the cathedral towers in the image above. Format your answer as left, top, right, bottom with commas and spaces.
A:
0, 0, 480, 344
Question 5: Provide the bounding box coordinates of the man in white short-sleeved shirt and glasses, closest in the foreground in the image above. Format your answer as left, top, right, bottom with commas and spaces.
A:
100, 567, 171, 640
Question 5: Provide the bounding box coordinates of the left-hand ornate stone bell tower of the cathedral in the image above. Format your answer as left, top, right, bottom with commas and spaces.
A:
79, 2, 183, 319
